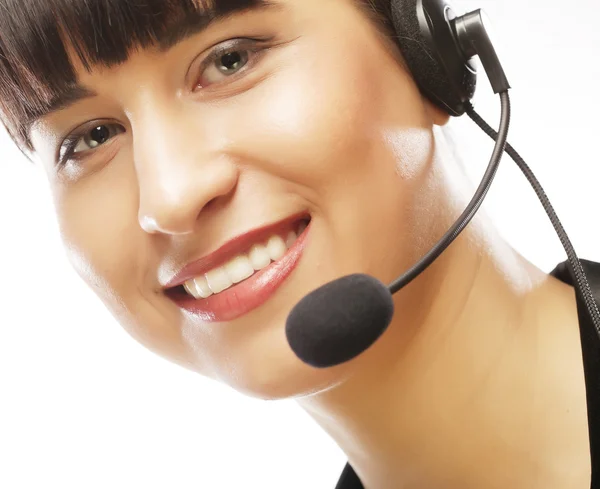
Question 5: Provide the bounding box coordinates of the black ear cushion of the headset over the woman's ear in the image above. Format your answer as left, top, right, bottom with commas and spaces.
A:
390, 0, 476, 116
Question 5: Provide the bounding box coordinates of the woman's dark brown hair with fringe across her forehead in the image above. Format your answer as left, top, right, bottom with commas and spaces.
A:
0, 0, 392, 151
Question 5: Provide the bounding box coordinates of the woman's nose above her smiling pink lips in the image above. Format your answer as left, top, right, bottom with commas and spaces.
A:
133, 111, 238, 235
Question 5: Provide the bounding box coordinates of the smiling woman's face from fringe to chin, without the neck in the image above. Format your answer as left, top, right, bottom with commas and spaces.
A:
32, 0, 444, 398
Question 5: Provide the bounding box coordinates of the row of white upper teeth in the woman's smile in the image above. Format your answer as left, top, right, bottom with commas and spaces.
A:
184, 222, 306, 299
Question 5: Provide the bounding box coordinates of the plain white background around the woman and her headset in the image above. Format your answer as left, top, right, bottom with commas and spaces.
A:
0, 0, 600, 489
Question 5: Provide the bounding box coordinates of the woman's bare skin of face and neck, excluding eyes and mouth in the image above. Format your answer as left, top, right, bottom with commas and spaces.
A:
25, 0, 590, 489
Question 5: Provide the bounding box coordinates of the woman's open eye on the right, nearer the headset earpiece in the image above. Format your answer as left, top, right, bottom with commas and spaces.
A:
195, 39, 264, 89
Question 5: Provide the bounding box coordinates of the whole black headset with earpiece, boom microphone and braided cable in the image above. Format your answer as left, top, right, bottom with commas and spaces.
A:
286, 0, 600, 368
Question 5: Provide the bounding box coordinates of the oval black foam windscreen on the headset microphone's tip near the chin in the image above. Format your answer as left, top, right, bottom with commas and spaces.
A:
285, 274, 394, 368
